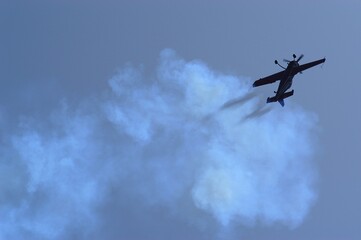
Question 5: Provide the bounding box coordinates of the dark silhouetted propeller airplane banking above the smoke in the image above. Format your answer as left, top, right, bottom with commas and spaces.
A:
253, 54, 326, 107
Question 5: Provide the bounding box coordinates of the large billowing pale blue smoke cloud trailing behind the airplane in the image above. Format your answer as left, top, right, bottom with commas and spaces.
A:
0, 49, 317, 239
